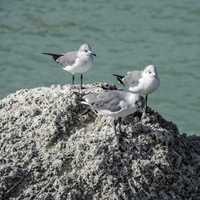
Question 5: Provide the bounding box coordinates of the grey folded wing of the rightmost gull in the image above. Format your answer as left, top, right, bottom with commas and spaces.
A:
123, 71, 142, 86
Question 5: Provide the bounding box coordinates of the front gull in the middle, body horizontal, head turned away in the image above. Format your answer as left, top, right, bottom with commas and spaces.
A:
82, 90, 144, 134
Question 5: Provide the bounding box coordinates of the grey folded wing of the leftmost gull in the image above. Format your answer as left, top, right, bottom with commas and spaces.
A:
56, 51, 77, 66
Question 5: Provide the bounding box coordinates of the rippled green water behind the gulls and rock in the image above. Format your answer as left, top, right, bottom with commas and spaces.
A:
0, 0, 200, 134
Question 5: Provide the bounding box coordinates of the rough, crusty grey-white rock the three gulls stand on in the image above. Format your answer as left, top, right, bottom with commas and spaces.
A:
0, 85, 200, 200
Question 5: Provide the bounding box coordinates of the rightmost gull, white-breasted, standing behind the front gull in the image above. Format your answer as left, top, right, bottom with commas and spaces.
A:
113, 65, 160, 114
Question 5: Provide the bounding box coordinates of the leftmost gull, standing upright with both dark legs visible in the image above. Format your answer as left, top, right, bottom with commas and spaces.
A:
42, 44, 96, 88
